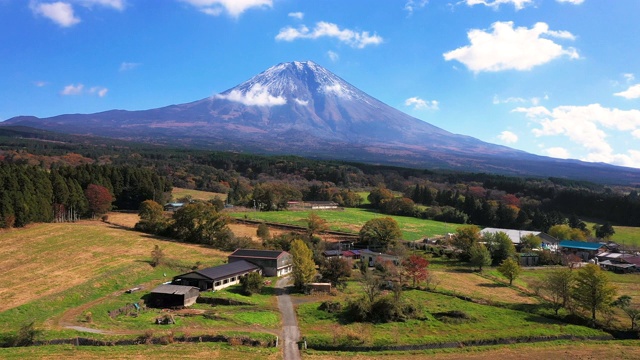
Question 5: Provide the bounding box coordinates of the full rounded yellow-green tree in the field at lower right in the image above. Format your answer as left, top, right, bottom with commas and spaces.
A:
572, 264, 617, 323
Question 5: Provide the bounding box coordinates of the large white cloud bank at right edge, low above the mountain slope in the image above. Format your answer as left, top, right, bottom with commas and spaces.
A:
513, 104, 640, 167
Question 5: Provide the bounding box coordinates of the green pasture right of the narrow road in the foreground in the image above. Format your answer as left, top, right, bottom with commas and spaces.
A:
298, 284, 606, 346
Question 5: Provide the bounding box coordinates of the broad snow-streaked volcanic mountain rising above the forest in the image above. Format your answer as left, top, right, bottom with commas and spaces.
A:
0, 61, 640, 184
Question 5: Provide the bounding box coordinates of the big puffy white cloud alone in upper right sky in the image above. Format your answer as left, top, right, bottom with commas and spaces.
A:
443, 21, 580, 73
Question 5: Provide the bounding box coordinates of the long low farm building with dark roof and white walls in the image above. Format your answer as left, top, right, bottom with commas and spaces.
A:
172, 260, 262, 291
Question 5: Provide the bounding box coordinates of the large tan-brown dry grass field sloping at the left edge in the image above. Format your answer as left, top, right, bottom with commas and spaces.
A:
0, 221, 226, 311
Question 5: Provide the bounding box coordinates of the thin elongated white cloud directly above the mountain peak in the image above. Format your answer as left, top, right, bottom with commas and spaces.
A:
276, 21, 383, 49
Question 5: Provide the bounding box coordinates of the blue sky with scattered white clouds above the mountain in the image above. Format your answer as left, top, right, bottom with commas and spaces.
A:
0, 0, 640, 168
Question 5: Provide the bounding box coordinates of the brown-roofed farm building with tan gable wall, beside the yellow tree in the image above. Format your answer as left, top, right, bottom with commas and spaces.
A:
229, 249, 293, 276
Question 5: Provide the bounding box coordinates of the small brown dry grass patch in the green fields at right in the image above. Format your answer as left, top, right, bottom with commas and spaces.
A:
434, 270, 538, 304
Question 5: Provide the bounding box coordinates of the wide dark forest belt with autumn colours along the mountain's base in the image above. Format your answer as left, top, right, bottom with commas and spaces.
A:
0, 127, 640, 231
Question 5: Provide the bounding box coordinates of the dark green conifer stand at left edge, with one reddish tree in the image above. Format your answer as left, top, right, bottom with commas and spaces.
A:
0, 162, 171, 228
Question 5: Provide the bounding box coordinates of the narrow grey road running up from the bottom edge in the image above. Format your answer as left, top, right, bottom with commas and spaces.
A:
276, 276, 300, 360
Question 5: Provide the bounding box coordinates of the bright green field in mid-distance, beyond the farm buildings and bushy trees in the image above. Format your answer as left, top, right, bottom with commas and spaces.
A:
229, 208, 461, 241
